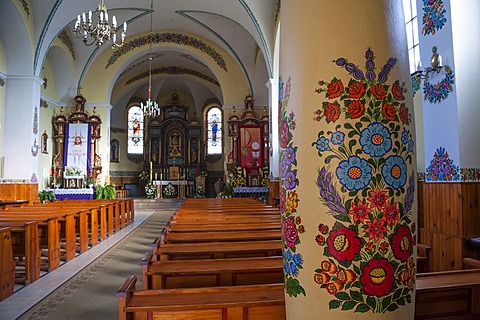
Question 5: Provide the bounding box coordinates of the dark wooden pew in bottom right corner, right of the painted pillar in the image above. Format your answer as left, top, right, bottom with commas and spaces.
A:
415, 269, 480, 320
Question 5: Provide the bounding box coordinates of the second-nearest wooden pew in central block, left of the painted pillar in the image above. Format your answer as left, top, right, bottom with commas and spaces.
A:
142, 252, 283, 290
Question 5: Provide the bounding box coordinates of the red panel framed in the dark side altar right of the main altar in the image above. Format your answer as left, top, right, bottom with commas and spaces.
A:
239, 125, 263, 169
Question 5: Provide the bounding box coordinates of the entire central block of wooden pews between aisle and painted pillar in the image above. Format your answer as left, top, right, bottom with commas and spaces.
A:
117, 198, 285, 320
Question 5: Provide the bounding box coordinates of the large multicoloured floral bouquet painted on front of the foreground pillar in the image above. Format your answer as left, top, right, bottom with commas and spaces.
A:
312, 49, 416, 313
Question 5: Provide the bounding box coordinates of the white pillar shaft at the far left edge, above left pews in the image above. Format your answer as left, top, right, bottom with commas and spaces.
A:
3, 76, 43, 182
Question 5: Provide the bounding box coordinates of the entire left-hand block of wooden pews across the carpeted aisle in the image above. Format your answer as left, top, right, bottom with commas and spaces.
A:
0, 199, 134, 301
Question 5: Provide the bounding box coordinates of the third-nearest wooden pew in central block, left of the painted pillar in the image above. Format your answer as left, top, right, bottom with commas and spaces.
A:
152, 238, 282, 261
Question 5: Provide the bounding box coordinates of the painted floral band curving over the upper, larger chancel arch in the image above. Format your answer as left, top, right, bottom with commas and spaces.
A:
105, 32, 228, 71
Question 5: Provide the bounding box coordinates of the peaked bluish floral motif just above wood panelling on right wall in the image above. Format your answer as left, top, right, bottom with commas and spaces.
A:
426, 147, 460, 181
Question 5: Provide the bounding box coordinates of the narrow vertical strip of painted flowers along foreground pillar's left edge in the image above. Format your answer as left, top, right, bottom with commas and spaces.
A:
279, 78, 305, 297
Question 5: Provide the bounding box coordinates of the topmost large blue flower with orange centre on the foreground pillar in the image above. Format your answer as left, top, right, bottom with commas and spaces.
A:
360, 122, 392, 158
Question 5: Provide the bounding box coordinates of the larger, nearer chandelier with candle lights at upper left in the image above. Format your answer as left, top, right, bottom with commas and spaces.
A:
73, 0, 127, 48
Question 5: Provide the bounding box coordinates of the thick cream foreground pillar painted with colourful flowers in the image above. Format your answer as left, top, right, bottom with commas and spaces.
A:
279, 0, 417, 320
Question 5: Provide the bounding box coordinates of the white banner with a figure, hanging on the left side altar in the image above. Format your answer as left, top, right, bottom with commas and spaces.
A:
64, 123, 90, 178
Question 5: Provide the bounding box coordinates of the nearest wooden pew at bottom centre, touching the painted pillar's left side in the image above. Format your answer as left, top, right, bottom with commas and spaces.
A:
116, 276, 286, 320
